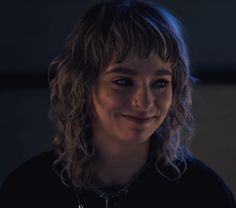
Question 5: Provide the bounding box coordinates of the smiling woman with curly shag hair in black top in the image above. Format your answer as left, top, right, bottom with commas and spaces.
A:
1, 1, 236, 208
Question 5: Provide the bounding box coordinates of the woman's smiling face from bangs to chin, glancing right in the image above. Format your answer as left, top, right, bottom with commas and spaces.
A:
92, 56, 172, 144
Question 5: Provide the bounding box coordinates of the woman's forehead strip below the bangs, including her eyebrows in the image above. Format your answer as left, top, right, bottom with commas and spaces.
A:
104, 56, 172, 75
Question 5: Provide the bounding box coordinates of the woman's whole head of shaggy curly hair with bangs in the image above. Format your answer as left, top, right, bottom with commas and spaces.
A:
49, 0, 192, 189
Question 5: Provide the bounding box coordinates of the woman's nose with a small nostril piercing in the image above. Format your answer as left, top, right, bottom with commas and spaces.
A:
132, 86, 155, 110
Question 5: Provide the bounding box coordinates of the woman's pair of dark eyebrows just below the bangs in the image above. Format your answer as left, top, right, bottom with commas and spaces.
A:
105, 67, 172, 76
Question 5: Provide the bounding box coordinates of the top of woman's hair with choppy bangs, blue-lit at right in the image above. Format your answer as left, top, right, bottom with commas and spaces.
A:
69, 2, 187, 77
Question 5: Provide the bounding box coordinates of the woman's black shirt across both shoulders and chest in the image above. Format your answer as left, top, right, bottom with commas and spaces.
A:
0, 151, 236, 208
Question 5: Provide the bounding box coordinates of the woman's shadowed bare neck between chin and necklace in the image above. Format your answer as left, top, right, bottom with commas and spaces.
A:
94, 141, 149, 186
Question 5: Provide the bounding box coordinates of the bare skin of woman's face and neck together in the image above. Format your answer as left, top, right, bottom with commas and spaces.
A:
91, 56, 172, 183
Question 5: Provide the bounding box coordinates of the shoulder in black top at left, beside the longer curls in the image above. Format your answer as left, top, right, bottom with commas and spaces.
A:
0, 151, 74, 208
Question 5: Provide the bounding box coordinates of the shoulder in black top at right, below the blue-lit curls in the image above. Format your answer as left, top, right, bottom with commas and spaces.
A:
177, 157, 236, 207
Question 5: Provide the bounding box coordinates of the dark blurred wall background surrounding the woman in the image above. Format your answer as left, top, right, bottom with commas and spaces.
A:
0, 0, 236, 197
